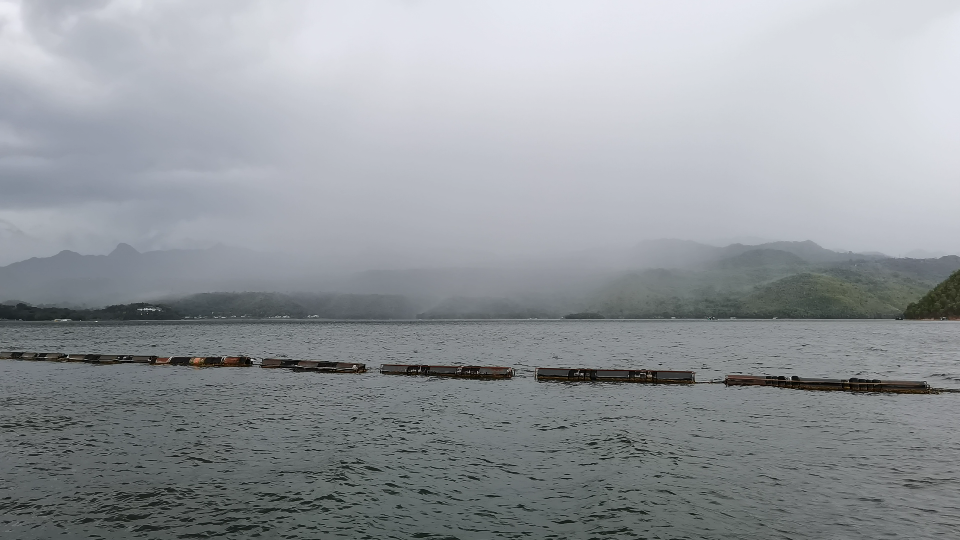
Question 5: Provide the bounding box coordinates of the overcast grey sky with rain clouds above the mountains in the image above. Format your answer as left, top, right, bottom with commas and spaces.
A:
0, 0, 960, 266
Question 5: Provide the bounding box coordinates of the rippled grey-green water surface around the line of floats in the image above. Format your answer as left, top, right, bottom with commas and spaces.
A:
0, 321, 960, 539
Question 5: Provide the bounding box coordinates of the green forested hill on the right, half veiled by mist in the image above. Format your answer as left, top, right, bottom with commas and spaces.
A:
581, 249, 960, 318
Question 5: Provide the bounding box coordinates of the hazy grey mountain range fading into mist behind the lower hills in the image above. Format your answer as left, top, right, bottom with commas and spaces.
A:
0, 239, 878, 305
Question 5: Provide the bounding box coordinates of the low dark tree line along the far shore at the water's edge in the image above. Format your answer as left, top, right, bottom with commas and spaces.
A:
0, 270, 960, 321
